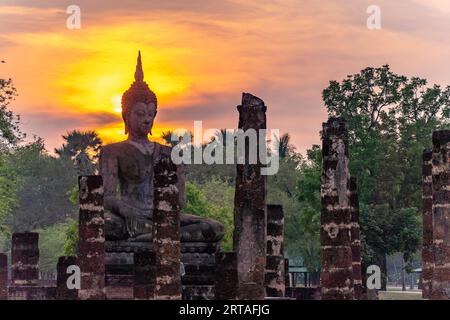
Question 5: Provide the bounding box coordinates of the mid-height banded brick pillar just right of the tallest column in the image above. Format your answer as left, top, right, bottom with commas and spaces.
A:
265, 205, 286, 297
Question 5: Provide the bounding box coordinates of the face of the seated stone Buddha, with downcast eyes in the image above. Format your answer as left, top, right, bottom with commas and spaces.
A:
127, 102, 156, 138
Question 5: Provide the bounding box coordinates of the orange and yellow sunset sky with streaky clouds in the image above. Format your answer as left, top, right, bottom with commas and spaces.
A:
0, 0, 450, 153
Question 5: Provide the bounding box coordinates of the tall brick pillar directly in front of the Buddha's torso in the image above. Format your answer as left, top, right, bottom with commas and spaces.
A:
153, 149, 182, 300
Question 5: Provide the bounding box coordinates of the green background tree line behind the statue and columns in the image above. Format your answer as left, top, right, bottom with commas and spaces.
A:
0, 66, 450, 284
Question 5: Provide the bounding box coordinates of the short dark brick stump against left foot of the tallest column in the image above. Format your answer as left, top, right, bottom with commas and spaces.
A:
214, 252, 238, 300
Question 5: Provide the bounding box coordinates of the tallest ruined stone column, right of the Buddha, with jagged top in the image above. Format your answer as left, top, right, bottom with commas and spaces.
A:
233, 93, 267, 300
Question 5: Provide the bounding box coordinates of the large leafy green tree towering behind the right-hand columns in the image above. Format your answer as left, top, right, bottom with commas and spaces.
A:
323, 65, 450, 288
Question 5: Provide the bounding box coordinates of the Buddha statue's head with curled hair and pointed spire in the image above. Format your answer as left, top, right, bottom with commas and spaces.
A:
122, 52, 158, 138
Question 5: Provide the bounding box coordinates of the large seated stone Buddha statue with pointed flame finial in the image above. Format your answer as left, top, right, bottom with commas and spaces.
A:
100, 52, 224, 242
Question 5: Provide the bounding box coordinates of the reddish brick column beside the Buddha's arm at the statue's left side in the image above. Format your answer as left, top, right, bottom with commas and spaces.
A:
77, 176, 106, 300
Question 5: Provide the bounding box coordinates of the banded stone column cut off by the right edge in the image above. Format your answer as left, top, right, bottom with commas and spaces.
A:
431, 130, 450, 300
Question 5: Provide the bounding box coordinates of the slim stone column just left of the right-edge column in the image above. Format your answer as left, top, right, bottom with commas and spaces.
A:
422, 150, 434, 299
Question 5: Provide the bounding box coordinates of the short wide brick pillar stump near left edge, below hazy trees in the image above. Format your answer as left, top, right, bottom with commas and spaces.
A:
11, 232, 39, 286
